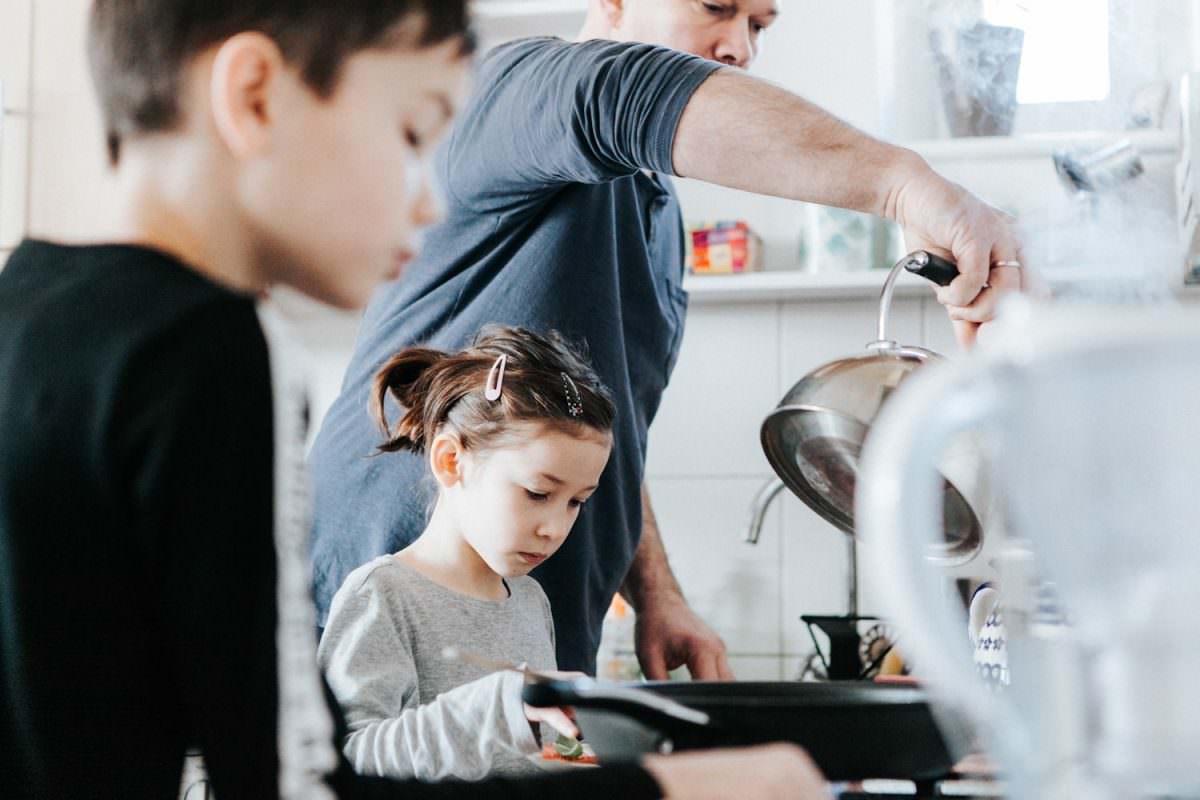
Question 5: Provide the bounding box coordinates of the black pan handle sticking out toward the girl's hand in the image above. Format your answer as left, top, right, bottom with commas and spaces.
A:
521, 678, 712, 730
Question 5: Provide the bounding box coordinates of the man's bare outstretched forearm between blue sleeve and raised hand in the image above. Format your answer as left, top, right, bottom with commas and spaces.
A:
673, 70, 929, 219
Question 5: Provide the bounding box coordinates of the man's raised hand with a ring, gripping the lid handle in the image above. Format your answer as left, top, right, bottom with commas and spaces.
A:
887, 153, 1022, 347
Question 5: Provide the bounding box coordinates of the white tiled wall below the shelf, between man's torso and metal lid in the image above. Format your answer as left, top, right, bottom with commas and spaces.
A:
647, 291, 936, 666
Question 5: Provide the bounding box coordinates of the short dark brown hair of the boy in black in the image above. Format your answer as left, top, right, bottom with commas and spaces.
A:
88, 0, 474, 164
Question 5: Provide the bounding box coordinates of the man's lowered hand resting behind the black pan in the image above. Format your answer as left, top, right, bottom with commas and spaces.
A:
634, 593, 733, 680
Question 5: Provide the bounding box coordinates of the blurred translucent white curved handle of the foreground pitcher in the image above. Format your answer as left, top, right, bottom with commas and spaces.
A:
854, 360, 1033, 798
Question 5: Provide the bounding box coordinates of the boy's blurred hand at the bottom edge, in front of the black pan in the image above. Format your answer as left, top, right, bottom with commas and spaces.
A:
643, 745, 830, 800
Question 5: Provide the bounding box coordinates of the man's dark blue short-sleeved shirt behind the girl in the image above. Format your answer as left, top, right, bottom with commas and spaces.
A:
312, 38, 718, 672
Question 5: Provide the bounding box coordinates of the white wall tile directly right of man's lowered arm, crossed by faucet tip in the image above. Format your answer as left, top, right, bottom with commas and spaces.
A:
647, 477, 781, 654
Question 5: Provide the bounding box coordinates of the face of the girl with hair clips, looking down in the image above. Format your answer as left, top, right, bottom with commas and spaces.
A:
442, 423, 612, 577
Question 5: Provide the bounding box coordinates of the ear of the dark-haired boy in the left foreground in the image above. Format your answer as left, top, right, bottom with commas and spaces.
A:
209, 32, 284, 158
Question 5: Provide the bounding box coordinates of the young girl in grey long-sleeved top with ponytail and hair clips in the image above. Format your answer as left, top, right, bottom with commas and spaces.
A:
318, 327, 614, 780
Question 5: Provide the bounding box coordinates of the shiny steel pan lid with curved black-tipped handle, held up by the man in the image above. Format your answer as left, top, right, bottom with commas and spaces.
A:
761, 251, 983, 565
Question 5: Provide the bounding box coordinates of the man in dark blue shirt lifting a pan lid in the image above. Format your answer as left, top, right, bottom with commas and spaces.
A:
312, 0, 1020, 679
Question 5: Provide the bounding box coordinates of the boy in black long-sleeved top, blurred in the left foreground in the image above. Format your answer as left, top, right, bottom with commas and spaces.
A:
0, 0, 825, 800
